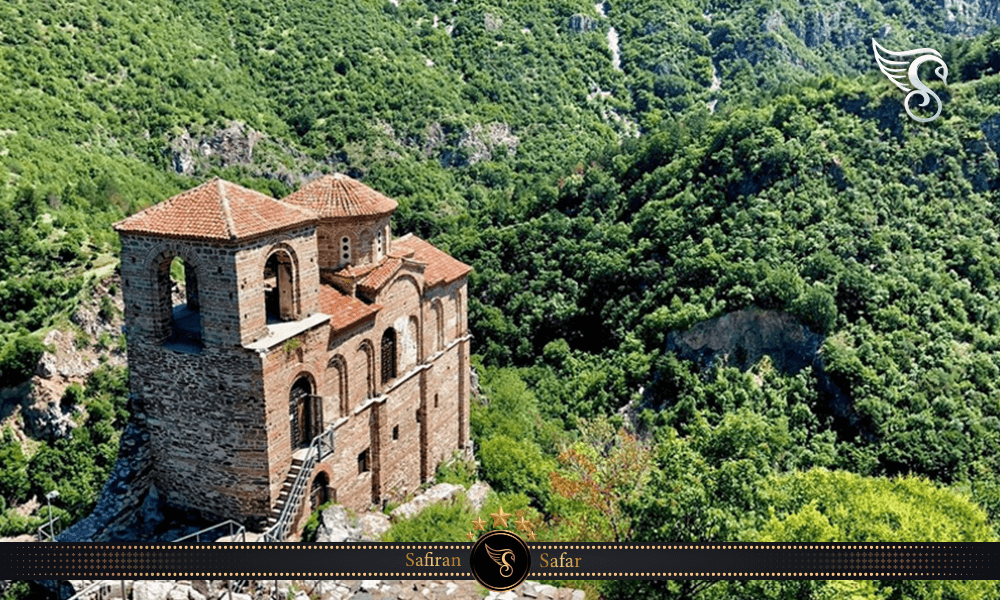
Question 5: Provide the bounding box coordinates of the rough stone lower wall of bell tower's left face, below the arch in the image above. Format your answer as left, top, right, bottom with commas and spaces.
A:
129, 342, 270, 520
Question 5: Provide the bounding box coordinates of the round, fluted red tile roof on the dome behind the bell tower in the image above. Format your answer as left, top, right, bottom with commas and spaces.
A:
284, 173, 399, 219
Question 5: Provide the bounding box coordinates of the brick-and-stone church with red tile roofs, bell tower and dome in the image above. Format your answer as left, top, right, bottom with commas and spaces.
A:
114, 174, 471, 530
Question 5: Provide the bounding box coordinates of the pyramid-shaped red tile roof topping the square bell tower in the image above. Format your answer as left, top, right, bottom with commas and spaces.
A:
114, 177, 316, 240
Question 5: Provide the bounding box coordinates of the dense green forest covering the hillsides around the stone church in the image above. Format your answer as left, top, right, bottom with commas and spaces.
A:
0, 0, 1000, 599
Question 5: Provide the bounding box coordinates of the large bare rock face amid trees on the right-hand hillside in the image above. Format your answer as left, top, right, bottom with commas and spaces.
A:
667, 307, 823, 373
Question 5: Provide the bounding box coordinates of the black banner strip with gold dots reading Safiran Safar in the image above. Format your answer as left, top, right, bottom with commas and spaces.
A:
0, 542, 1000, 579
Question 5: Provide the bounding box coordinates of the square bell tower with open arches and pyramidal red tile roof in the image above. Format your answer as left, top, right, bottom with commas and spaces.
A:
115, 178, 319, 520
